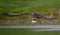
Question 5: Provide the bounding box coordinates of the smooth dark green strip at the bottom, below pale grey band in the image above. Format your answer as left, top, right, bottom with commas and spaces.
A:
0, 28, 60, 35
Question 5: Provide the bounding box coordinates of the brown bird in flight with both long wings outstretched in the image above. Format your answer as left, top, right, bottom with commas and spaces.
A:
4, 13, 55, 20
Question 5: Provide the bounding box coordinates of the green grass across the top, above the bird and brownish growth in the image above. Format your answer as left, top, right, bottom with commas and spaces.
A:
0, 0, 60, 13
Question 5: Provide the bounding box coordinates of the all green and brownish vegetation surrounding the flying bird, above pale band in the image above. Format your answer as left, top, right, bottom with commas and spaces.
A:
0, 0, 60, 24
